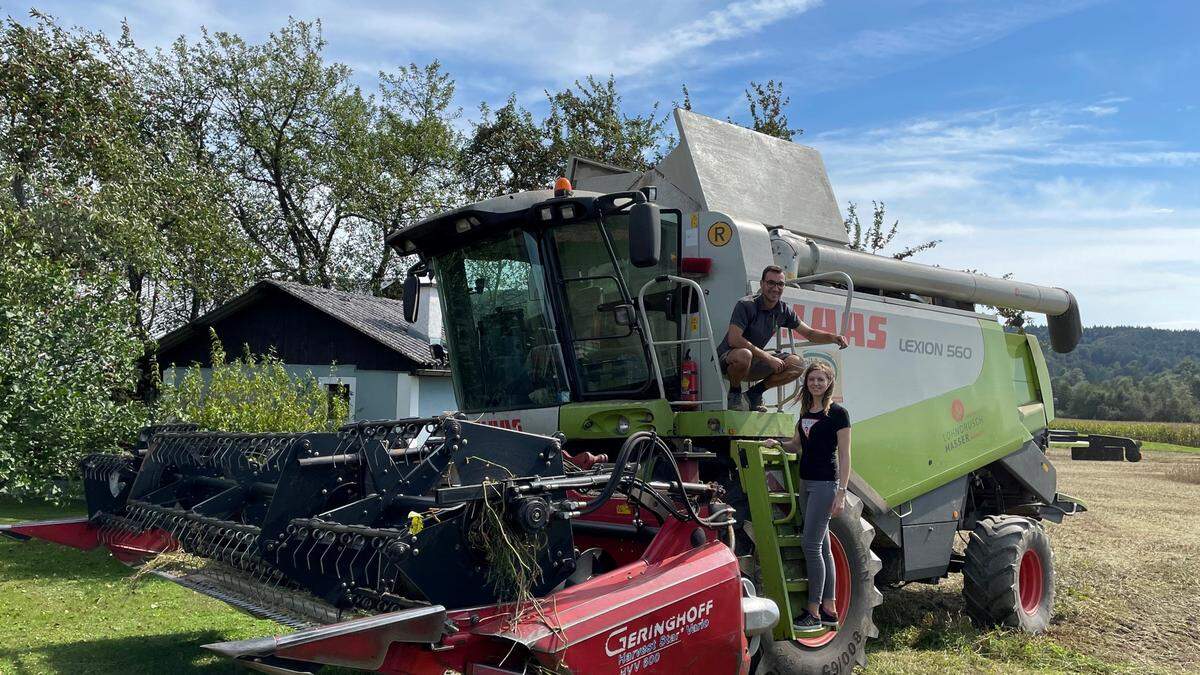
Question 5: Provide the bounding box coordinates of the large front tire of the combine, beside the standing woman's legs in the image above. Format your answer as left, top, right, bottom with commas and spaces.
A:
755, 487, 883, 675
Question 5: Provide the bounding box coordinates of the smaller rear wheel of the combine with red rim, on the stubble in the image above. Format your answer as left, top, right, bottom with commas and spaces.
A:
962, 515, 1055, 633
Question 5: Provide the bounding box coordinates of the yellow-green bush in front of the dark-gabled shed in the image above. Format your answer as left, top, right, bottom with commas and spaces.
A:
158, 331, 349, 434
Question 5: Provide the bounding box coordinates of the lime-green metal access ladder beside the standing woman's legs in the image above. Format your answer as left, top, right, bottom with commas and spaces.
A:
733, 441, 809, 640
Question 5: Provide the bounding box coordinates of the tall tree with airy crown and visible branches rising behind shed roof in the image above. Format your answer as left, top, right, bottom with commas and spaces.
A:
173, 19, 461, 293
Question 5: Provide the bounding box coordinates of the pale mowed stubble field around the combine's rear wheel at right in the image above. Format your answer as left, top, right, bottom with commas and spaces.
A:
868, 448, 1200, 673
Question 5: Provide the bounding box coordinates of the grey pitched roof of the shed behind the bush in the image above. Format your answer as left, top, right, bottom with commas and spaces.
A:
158, 279, 443, 366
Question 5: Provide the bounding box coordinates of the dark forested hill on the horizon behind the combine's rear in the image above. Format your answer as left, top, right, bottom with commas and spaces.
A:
1027, 325, 1200, 422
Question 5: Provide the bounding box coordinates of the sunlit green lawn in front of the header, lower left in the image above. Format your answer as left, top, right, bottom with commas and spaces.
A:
0, 500, 287, 674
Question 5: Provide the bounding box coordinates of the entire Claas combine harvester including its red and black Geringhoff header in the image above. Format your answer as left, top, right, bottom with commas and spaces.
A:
6, 110, 1082, 675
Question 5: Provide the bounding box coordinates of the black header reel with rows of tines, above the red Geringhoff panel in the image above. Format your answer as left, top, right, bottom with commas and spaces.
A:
84, 417, 727, 626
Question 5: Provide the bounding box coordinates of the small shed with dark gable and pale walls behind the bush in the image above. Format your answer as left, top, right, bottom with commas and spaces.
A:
157, 280, 457, 419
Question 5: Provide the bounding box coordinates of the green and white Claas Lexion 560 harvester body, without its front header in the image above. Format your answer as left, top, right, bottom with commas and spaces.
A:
390, 109, 1084, 673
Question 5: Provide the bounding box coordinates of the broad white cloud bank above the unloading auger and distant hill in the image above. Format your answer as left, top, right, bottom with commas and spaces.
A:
811, 104, 1200, 324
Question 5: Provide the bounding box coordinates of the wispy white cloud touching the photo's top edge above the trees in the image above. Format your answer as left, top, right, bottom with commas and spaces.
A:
322, 0, 821, 83
